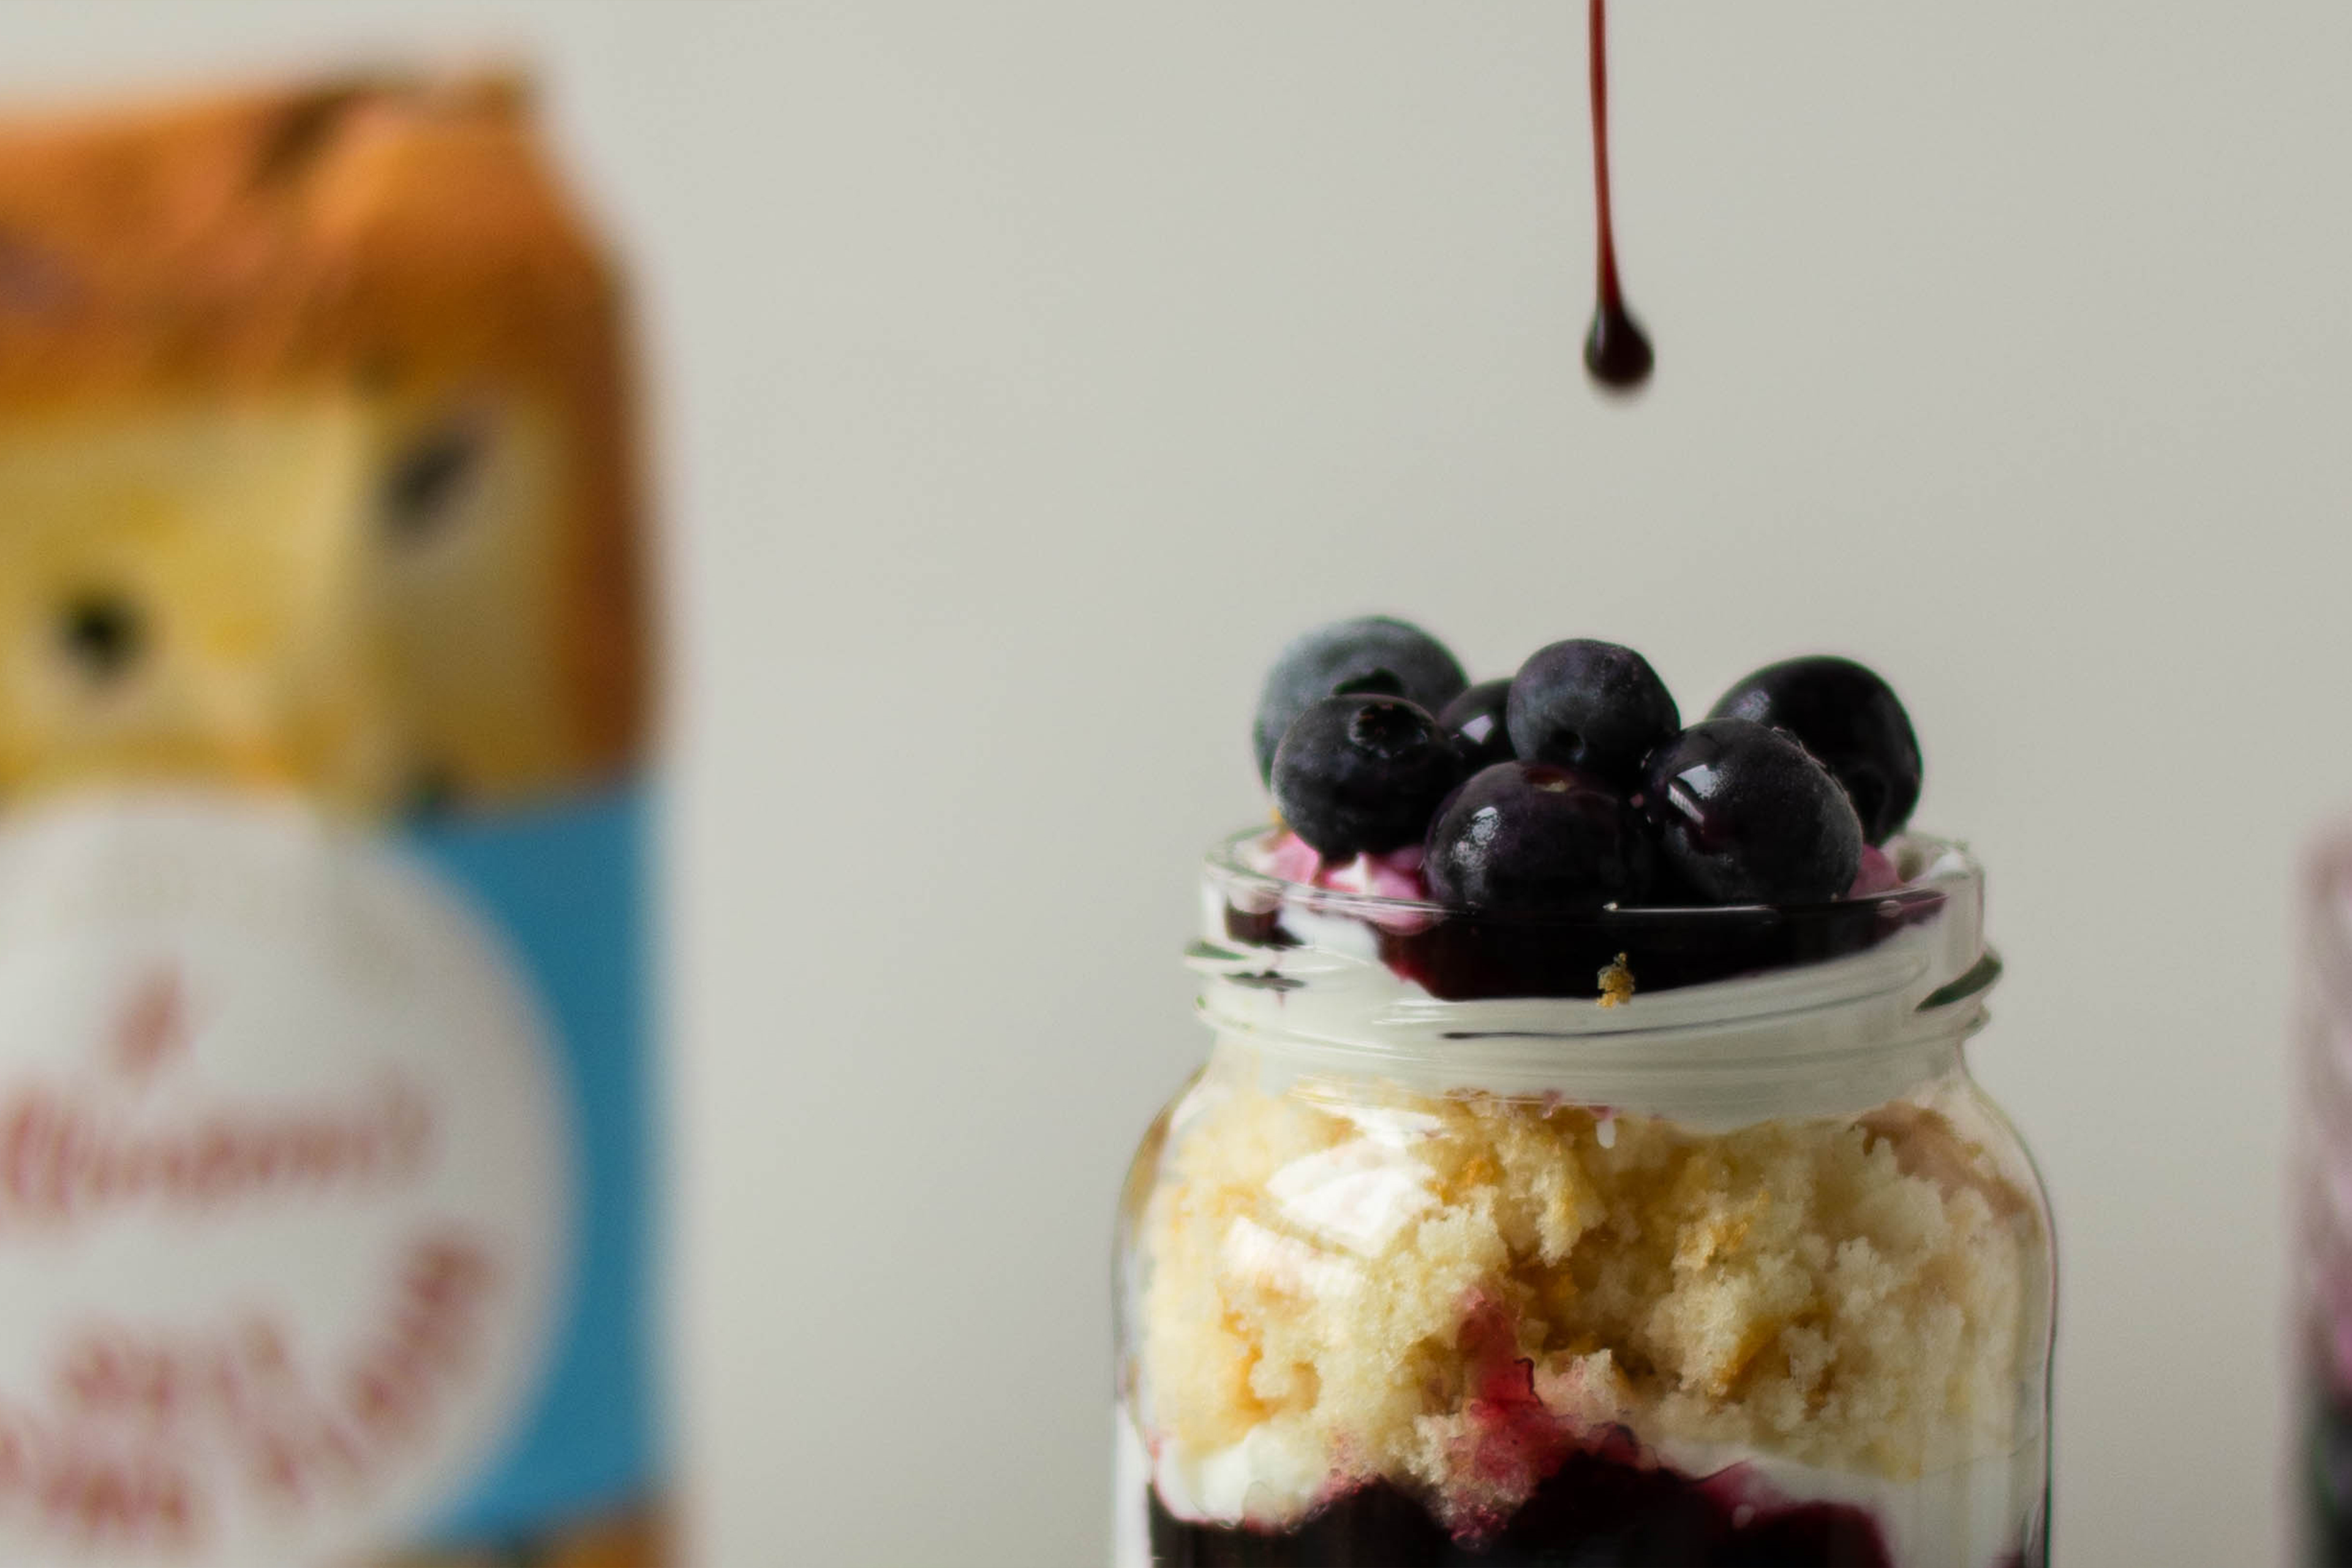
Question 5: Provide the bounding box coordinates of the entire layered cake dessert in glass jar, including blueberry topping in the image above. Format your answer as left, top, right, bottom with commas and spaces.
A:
1115, 618, 2053, 1568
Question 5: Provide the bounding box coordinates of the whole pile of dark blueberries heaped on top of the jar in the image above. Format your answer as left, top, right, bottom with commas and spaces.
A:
1256, 616, 1919, 912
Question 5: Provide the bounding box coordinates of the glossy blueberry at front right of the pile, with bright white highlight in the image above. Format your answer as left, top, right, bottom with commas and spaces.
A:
1642, 719, 1863, 903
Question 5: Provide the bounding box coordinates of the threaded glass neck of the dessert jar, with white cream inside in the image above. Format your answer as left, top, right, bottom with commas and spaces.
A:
1190, 827, 2002, 1121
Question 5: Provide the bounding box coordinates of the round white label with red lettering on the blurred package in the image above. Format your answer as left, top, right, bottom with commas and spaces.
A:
0, 794, 574, 1568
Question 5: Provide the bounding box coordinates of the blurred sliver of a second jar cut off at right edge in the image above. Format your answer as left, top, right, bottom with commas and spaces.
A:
2293, 835, 2352, 1568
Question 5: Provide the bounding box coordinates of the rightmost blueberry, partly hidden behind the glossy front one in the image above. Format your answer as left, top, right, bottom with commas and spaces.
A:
1708, 656, 1919, 844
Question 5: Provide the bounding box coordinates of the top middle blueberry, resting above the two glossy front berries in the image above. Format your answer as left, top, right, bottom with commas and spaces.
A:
1507, 637, 1682, 788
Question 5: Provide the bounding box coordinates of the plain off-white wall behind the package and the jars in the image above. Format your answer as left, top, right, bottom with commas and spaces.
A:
0, 0, 2352, 1568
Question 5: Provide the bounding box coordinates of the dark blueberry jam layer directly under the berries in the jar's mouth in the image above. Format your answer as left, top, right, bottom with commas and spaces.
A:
1226, 889, 1945, 1001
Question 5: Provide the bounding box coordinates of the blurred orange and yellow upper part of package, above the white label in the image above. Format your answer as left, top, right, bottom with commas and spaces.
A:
0, 78, 644, 813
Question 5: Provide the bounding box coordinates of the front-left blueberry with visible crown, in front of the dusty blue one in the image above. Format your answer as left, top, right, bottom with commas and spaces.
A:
1275, 693, 1461, 861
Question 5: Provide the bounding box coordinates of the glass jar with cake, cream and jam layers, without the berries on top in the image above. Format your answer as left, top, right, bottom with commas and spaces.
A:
1115, 832, 2053, 1568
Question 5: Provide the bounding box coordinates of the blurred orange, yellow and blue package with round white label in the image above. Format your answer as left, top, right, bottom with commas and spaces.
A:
0, 78, 661, 1568
